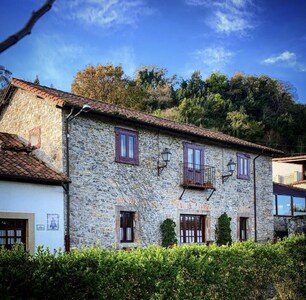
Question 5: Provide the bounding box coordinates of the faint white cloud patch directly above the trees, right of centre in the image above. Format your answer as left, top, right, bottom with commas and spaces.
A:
194, 47, 234, 70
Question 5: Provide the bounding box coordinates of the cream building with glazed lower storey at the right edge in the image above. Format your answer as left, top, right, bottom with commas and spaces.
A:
272, 155, 306, 237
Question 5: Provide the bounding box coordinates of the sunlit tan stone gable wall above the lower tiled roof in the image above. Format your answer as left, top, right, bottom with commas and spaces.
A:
0, 89, 63, 171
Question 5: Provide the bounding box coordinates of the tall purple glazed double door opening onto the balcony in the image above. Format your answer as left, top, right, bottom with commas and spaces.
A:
184, 143, 204, 185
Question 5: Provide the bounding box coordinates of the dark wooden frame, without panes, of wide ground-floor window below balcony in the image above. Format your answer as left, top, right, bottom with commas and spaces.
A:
179, 214, 206, 244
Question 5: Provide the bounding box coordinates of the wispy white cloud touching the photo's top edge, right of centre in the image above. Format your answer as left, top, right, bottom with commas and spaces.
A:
185, 0, 254, 34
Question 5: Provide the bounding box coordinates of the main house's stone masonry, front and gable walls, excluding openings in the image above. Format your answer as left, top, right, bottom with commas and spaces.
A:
0, 89, 273, 248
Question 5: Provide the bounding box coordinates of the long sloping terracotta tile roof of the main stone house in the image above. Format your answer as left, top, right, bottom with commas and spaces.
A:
0, 78, 283, 155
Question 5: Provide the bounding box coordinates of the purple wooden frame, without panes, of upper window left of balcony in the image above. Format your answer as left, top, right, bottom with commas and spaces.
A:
115, 127, 139, 165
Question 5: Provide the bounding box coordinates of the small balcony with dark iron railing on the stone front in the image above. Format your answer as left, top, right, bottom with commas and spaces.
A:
182, 163, 215, 190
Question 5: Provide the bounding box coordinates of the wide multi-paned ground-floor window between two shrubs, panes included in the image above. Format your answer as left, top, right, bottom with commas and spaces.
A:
180, 215, 205, 243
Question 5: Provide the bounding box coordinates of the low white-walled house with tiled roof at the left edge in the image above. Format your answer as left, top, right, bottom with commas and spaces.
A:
0, 132, 68, 253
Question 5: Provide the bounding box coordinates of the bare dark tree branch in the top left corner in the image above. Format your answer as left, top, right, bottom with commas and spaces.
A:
0, 0, 55, 53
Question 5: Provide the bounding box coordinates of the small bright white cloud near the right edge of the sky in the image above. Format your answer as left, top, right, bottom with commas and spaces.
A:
262, 51, 306, 72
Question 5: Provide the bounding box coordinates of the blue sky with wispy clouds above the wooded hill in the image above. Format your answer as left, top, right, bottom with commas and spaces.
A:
0, 0, 306, 103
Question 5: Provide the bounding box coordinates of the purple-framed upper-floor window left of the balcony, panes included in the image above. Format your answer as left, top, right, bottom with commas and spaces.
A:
115, 128, 139, 165
